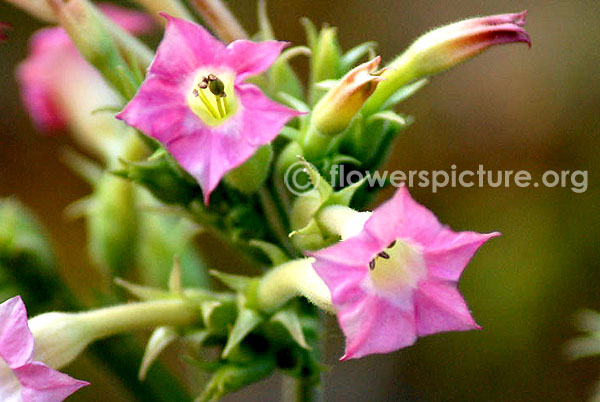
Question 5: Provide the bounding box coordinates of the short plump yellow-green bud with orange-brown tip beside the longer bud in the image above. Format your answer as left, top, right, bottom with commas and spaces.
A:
312, 56, 384, 136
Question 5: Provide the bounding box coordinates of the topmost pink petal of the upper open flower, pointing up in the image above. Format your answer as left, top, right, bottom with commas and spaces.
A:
149, 13, 225, 78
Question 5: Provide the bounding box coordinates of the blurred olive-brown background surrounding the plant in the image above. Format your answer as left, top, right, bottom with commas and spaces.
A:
0, 0, 600, 401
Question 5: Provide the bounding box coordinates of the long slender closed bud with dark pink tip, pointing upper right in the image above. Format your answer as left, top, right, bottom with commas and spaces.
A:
363, 11, 531, 114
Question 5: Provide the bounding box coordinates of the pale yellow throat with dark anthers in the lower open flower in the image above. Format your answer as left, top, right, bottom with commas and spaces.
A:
369, 240, 427, 292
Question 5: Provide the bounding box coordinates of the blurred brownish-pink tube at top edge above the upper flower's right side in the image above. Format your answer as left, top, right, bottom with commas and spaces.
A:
191, 0, 248, 42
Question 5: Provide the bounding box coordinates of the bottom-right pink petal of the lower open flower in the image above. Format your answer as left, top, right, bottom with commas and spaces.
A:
414, 280, 480, 336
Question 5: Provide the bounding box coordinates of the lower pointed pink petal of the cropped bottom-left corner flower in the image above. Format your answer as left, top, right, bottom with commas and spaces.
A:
14, 362, 89, 402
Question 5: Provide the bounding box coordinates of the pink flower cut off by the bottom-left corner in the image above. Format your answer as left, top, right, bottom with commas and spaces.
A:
0, 296, 89, 402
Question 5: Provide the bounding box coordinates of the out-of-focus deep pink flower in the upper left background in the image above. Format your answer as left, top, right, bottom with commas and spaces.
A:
17, 4, 153, 133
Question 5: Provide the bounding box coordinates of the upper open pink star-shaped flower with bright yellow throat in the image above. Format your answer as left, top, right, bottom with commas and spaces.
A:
117, 14, 300, 203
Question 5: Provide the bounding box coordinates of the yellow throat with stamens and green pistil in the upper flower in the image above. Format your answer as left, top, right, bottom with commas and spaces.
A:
187, 71, 238, 126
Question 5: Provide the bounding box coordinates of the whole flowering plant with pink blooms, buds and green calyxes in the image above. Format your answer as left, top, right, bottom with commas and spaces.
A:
0, 0, 530, 402
